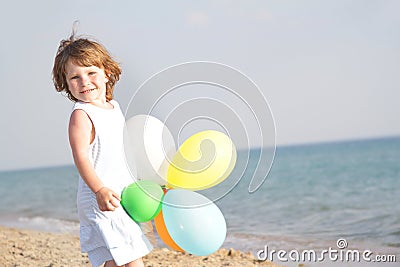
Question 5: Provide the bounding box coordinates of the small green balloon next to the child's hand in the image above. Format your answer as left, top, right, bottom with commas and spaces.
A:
121, 180, 164, 222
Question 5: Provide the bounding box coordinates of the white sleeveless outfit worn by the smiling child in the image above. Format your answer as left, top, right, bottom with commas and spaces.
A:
74, 100, 152, 266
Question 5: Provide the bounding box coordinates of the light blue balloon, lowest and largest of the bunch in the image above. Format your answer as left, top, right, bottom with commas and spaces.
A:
162, 189, 226, 256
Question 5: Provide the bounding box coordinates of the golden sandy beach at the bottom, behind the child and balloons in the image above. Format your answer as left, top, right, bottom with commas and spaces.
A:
0, 227, 278, 267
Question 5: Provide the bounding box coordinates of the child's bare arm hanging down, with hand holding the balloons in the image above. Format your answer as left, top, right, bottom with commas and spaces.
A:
68, 109, 121, 211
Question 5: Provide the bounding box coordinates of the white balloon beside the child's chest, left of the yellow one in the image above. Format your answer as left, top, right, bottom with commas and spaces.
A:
124, 115, 176, 185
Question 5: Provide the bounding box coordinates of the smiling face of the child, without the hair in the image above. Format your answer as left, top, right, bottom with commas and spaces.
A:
65, 60, 108, 106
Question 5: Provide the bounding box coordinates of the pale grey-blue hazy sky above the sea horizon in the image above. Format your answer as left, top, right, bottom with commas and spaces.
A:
0, 0, 400, 170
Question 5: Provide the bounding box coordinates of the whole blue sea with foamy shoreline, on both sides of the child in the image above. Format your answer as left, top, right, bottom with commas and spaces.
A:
0, 137, 400, 266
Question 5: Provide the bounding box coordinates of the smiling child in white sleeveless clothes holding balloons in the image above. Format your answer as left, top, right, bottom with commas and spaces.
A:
53, 34, 152, 267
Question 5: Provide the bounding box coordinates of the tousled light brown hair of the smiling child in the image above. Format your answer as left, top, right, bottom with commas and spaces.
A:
53, 34, 121, 102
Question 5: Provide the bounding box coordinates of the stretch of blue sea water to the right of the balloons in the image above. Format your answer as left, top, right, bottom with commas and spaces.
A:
220, 138, 400, 253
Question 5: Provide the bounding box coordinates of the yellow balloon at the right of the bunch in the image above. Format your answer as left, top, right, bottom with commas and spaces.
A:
167, 130, 236, 190
